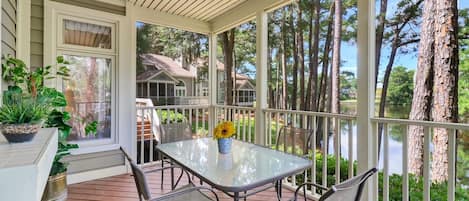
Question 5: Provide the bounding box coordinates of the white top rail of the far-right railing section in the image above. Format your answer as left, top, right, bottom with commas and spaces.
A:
371, 118, 469, 130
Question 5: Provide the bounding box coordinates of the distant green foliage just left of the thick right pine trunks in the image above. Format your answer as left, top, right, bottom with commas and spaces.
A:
387, 66, 414, 106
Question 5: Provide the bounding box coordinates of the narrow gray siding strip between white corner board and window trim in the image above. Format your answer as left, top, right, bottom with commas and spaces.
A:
30, 0, 44, 68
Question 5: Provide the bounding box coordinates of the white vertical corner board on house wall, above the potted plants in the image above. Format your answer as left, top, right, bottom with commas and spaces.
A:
16, 0, 31, 67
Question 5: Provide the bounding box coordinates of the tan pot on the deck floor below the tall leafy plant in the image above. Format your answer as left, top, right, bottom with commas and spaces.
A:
42, 172, 67, 201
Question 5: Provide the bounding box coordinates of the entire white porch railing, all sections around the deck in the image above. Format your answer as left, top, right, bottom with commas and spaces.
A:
137, 105, 469, 201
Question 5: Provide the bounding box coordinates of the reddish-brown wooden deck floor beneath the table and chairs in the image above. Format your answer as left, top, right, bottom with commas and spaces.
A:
68, 166, 304, 201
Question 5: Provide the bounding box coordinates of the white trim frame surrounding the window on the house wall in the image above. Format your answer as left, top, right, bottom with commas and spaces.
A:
44, 0, 136, 157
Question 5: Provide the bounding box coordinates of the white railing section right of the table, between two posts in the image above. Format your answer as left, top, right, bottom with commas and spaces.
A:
264, 109, 356, 198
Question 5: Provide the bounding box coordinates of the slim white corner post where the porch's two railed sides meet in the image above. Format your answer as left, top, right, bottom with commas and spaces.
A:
208, 33, 218, 135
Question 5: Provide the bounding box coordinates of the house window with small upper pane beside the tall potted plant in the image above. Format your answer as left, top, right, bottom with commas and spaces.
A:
56, 15, 117, 143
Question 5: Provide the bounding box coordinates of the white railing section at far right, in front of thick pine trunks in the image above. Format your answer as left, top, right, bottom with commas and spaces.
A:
371, 118, 469, 201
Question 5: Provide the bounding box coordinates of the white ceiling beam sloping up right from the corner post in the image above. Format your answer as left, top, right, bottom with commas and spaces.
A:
209, 0, 292, 33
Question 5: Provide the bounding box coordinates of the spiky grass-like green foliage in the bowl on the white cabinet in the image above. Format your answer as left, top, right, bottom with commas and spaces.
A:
0, 100, 49, 124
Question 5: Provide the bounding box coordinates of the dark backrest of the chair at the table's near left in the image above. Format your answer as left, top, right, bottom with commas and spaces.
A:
121, 147, 151, 200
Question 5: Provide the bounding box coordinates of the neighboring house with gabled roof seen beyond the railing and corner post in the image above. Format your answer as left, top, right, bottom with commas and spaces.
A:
137, 54, 255, 106
